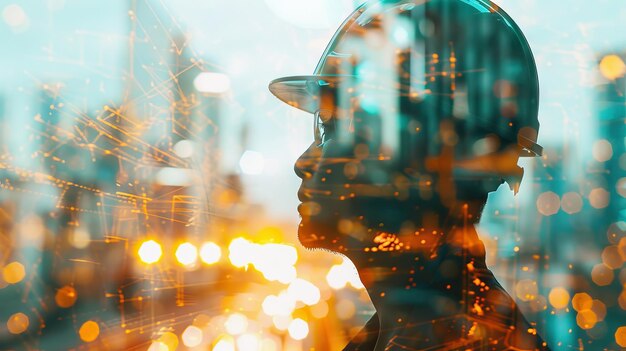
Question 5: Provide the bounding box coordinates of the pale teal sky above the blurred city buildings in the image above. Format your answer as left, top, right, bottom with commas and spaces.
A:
0, 0, 626, 218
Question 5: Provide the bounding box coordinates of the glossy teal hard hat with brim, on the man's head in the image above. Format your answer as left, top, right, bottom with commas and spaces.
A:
269, 0, 543, 160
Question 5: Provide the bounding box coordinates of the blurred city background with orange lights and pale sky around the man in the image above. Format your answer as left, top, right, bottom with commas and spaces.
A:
0, 0, 626, 351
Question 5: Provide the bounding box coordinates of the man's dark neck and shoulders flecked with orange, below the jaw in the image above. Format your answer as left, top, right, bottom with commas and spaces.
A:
342, 204, 547, 351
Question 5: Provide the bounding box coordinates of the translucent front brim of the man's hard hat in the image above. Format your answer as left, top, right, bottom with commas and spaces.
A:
269, 75, 350, 113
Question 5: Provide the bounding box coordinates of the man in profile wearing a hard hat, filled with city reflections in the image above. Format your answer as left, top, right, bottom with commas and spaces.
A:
270, 0, 548, 350
